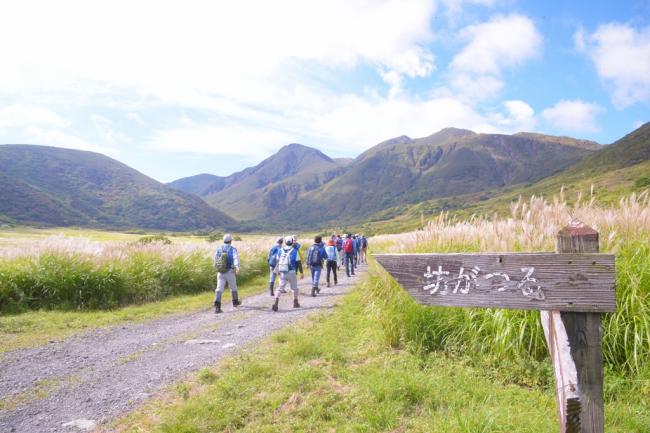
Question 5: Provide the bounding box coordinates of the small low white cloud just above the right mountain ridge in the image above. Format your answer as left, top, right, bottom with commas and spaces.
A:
542, 99, 604, 133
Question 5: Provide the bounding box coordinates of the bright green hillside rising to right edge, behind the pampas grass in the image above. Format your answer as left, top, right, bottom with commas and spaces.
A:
366, 123, 650, 232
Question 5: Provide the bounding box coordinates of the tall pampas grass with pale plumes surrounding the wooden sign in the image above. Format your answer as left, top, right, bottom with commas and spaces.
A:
366, 192, 650, 388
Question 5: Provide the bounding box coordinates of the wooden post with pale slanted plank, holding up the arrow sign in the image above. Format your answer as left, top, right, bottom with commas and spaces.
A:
541, 221, 605, 433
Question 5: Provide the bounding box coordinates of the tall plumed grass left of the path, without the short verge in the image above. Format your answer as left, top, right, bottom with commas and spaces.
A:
0, 231, 273, 313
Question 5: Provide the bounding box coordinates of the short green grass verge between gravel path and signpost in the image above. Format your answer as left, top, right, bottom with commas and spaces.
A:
105, 286, 650, 433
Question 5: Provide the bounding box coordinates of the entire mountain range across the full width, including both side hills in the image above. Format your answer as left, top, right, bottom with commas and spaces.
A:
0, 123, 650, 231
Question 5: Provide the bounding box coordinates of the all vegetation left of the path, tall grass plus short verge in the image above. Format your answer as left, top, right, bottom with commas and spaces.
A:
0, 229, 273, 353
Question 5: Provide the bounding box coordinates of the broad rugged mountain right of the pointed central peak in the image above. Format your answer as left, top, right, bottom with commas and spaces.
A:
279, 128, 600, 227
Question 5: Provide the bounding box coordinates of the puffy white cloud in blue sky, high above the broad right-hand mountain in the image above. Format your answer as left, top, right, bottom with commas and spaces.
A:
450, 14, 542, 101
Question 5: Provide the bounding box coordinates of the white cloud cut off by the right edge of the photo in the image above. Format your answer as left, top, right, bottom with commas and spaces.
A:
574, 23, 650, 109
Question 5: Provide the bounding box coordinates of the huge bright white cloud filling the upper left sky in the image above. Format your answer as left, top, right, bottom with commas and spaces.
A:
0, 0, 435, 103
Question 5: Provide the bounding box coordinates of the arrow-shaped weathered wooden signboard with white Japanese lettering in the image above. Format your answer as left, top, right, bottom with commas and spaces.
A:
374, 253, 616, 312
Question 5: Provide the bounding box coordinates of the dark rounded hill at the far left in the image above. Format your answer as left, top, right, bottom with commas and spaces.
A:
0, 145, 233, 231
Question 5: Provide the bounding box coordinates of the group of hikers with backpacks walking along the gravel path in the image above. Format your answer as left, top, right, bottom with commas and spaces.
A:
214, 233, 368, 314
